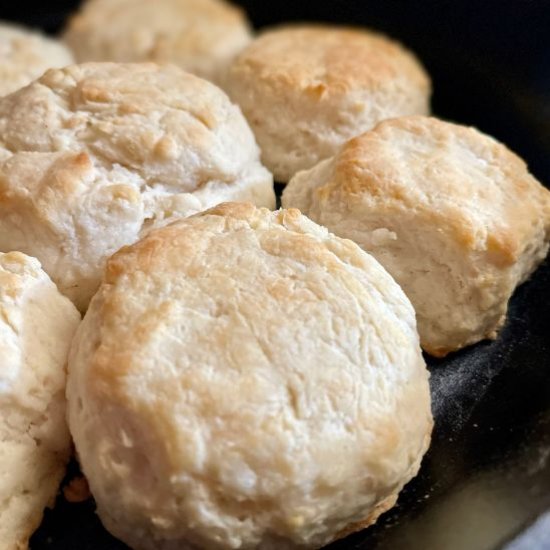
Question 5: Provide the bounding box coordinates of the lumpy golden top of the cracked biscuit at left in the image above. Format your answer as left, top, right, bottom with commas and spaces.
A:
0, 63, 257, 194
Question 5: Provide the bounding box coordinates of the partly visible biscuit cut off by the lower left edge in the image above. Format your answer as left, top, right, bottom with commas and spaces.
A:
0, 252, 80, 550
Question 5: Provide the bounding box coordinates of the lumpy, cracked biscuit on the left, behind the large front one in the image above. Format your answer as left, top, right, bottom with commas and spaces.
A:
0, 63, 275, 310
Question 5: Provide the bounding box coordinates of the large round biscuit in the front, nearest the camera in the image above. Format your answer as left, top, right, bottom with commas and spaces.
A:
68, 203, 432, 550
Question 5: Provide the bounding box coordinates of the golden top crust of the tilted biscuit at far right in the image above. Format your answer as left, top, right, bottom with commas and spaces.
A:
316, 116, 550, 264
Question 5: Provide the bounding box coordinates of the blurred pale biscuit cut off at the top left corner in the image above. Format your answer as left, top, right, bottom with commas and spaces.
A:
0, 23, 73, 97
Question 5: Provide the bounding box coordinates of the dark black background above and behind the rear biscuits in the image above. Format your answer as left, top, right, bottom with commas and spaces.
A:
0, 0, 550, 182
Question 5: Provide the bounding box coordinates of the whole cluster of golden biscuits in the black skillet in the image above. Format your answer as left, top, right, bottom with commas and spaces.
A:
0, 0, 550, 550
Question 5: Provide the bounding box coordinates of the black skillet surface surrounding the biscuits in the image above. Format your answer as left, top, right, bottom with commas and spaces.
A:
0, 0, 550, 550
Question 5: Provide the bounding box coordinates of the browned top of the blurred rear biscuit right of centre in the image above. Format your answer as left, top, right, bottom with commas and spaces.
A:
232, 25, 430, 98
